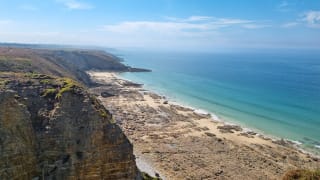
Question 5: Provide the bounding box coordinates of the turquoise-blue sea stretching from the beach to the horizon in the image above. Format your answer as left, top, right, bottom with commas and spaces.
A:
118, 51, 320, 152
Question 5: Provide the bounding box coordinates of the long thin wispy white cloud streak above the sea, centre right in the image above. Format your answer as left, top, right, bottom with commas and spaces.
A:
103, 16, 267, 33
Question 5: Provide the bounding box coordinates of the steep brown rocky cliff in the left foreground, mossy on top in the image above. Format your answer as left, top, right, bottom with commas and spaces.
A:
0, 73, 139, 179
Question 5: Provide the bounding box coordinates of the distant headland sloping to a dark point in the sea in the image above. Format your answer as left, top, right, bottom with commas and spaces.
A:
0, 45, 148, 86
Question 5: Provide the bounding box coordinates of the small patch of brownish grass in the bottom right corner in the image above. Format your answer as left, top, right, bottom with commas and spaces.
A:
282, 169, 320, 180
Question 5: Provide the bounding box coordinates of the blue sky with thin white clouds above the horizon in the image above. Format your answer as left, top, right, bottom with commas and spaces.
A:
0, 0, 320, 51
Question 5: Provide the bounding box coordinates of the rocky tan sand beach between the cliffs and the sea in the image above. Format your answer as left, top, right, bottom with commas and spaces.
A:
88, 72, 320, 179
